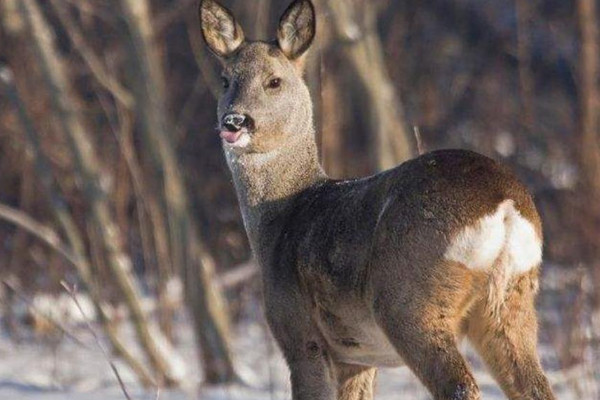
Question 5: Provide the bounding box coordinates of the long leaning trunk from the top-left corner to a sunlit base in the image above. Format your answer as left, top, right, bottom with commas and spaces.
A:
14, 0, 181, 386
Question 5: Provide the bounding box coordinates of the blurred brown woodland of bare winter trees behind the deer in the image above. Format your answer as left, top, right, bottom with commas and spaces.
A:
0, 0, 600, 399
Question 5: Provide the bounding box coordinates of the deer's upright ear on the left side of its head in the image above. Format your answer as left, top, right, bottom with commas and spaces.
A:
199, 0, 244, 57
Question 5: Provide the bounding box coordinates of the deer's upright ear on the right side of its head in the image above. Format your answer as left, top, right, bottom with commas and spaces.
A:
277, 0, 316, 60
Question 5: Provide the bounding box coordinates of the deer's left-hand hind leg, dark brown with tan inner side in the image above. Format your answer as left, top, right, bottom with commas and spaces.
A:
374, 262, 481, 400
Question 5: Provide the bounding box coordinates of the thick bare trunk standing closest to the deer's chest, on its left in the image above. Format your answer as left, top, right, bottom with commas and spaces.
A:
121, 0, 237, 383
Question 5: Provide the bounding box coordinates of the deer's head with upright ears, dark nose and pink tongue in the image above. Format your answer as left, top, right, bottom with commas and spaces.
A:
200, 0, 315, 153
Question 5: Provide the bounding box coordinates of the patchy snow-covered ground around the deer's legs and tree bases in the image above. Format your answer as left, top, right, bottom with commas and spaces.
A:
0, 264, 600, 400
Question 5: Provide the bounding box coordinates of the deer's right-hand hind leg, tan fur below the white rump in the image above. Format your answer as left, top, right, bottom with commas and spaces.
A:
467, 269, 554, 400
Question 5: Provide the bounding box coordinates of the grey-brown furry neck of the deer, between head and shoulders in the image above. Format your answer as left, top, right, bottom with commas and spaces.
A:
225, 131, 327, 255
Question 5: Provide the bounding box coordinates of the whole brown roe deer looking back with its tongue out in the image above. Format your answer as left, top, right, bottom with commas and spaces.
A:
200, 0, 554, 400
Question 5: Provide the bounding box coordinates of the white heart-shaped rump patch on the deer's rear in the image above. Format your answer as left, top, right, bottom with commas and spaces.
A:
444, 200, 542, 275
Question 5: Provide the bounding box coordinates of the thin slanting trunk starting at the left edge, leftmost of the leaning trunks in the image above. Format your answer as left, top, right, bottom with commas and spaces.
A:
0, 65, 155, 387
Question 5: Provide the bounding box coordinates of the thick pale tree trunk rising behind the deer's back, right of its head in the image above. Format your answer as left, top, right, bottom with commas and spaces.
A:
327, 0, 412, 170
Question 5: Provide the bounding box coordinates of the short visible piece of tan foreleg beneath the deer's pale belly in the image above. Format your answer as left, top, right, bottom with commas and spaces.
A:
337, 364, 377, 400
